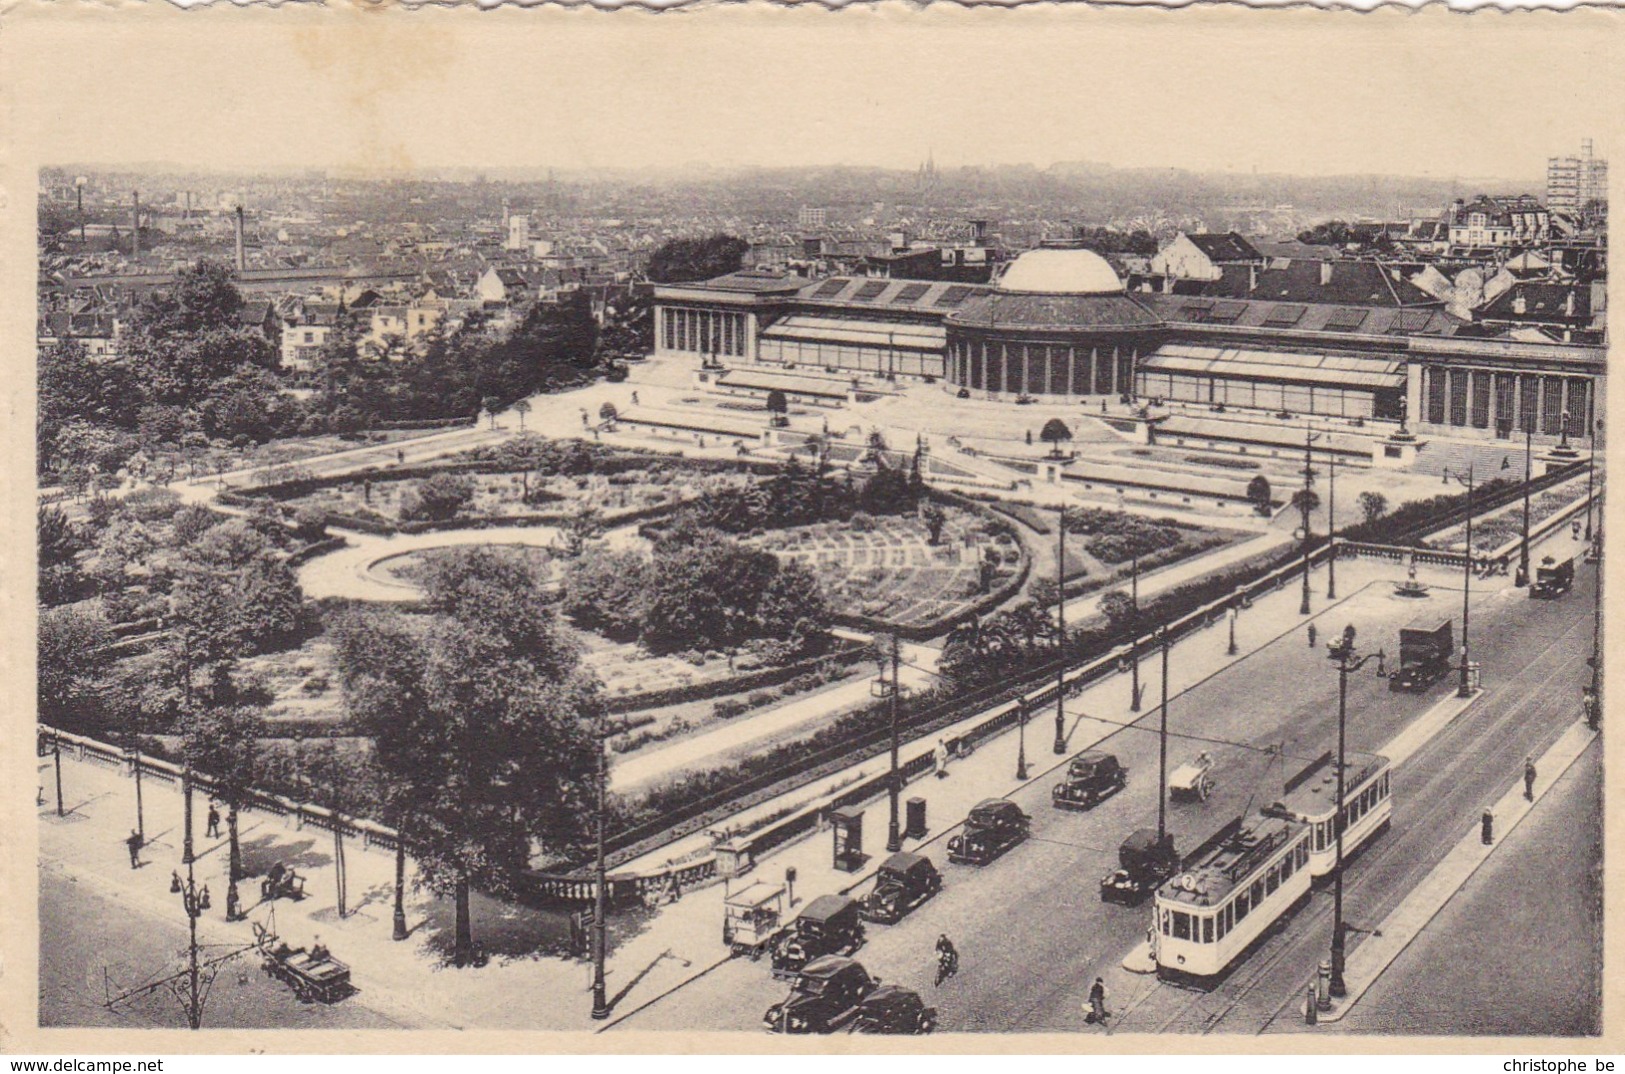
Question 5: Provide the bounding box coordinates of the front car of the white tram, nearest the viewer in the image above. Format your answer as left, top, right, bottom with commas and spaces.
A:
1152, 812, 1313, 981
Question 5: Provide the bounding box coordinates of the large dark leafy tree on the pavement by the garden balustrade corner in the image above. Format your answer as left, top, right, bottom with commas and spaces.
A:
336, 549, 603, 965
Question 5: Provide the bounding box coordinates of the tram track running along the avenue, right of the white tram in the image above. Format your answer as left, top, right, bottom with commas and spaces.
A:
1118, 597, 1584, 1033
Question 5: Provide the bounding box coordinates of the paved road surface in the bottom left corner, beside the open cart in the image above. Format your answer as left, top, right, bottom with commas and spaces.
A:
39, 863, 398, 1029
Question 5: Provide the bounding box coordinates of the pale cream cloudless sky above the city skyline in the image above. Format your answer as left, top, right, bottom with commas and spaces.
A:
8, 6, 1625, 177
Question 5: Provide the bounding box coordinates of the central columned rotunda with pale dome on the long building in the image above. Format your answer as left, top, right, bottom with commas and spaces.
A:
944, 249, 1162, 398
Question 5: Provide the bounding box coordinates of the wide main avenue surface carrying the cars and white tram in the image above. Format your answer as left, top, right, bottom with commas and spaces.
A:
626, 552, 1593, 1032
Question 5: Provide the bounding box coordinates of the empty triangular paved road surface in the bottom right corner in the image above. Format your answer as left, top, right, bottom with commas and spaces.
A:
1337, 741, 1602, 1037
